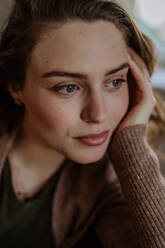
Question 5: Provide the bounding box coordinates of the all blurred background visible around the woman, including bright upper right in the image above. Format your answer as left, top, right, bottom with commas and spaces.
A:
0, 0, 165, 175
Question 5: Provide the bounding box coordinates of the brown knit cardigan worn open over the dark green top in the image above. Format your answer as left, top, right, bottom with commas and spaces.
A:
0, 125, 165, 248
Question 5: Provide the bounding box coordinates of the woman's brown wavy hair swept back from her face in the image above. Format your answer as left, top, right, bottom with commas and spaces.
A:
0, 0, 165, 153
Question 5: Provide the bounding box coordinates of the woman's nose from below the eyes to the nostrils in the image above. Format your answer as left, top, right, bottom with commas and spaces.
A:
81, 91, 107, 123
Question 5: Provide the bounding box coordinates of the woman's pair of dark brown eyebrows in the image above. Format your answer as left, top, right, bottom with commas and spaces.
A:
42, 63, 129, 79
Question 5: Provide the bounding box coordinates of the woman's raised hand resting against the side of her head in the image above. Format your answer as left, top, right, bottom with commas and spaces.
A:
116, 48, 156, 132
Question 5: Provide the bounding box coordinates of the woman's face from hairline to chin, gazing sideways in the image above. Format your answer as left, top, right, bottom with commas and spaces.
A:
18, 21, 129, 164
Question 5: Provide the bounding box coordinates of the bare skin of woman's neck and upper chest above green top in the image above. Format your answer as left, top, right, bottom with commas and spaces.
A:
9, 127, 65, 202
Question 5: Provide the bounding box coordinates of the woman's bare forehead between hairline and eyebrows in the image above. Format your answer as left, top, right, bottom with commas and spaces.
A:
30, 21, 127, 74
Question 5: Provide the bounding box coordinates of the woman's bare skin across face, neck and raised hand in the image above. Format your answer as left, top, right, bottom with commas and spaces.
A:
10, 21, 155, 198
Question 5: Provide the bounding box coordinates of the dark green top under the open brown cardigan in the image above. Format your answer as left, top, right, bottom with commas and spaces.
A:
0, 160, 64, 248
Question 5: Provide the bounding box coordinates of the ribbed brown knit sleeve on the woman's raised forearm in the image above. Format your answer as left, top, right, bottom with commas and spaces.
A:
110, 124, 165, 248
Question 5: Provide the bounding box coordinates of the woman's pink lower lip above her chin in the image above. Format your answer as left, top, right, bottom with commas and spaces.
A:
78, 131, 109, 146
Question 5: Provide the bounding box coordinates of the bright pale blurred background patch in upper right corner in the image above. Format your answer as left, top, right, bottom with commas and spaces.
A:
119, 0, 165, 90
